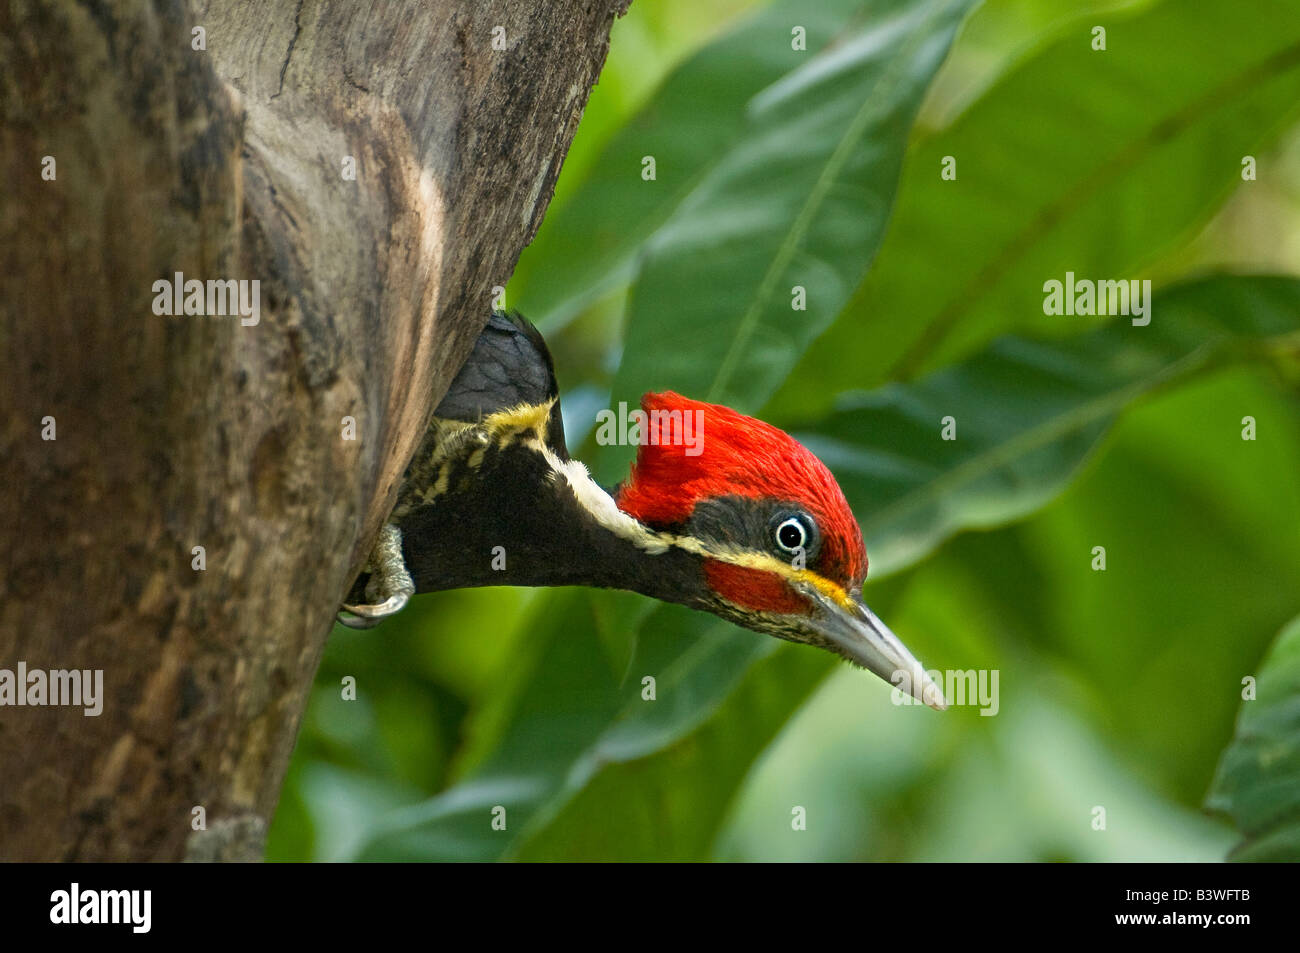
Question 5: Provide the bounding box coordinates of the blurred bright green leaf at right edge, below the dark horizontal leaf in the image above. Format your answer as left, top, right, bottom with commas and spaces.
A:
1008, 363, 1300, 800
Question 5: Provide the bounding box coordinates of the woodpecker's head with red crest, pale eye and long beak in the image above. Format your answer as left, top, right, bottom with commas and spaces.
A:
616, 393, 946, 709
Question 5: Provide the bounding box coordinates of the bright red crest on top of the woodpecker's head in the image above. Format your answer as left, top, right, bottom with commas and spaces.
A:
618, 391, 867, 598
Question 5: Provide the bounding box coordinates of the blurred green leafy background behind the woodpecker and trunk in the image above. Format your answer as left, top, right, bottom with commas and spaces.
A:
268, 0, 1300, 861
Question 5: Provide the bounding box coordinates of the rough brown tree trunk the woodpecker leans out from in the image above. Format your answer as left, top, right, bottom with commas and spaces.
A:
0, 0, 627, 861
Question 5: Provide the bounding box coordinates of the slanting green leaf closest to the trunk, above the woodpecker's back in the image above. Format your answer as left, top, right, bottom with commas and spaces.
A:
512, 0, 898, 332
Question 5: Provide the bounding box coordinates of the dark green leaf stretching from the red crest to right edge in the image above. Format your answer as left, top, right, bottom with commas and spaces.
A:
801, 278, 1300, 577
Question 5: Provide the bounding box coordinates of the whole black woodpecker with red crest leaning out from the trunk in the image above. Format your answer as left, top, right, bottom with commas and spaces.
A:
339, 312, 946, 709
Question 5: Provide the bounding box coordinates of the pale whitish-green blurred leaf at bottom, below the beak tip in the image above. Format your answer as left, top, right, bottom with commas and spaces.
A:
715, 670, 1231, 863
